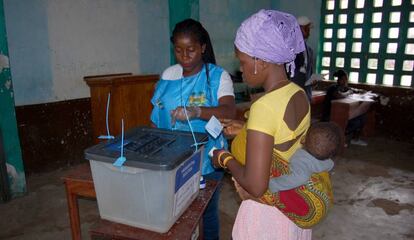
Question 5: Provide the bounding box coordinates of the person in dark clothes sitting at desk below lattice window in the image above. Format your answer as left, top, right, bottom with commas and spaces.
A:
321, 69, 371, 146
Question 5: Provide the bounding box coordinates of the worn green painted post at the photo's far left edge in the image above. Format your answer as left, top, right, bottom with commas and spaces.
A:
0, 1, 26, 197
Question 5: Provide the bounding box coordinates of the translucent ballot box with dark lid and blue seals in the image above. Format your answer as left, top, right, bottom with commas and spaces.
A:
85, 127, 207, 233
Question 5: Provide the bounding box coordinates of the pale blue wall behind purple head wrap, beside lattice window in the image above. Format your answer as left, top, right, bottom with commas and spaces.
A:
200, 0, 322, 73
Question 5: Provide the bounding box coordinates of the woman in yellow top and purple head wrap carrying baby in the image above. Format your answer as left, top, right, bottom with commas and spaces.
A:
213, 10, 332, 239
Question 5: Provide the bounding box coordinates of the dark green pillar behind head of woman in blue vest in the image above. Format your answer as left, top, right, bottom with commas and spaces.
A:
168, 0, 200, 64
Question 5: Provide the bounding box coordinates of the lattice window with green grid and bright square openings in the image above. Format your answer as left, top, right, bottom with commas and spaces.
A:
318, 0, 414, 88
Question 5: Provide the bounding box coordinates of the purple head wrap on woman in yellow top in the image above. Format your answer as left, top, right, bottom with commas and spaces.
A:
234, 9, 305, 77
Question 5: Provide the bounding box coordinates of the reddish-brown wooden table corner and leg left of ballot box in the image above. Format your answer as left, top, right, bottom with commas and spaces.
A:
62, 163, 96, 240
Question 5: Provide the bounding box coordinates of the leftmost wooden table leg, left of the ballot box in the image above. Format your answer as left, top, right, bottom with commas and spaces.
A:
65, 182, 82, 240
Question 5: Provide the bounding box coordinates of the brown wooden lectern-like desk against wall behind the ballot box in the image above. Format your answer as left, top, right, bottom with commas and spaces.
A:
84, 73, 159, 143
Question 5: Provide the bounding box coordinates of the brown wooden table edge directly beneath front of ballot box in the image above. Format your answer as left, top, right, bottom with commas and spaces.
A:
89, 181, 218, 240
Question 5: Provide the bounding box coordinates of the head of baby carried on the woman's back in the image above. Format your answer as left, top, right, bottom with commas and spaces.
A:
304, 122, 343, 160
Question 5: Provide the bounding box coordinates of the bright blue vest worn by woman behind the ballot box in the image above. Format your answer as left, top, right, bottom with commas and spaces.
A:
151, 64, 227, 175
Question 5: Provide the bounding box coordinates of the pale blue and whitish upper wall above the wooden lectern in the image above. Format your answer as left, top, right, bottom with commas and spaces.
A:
4, 0, 169, 106
